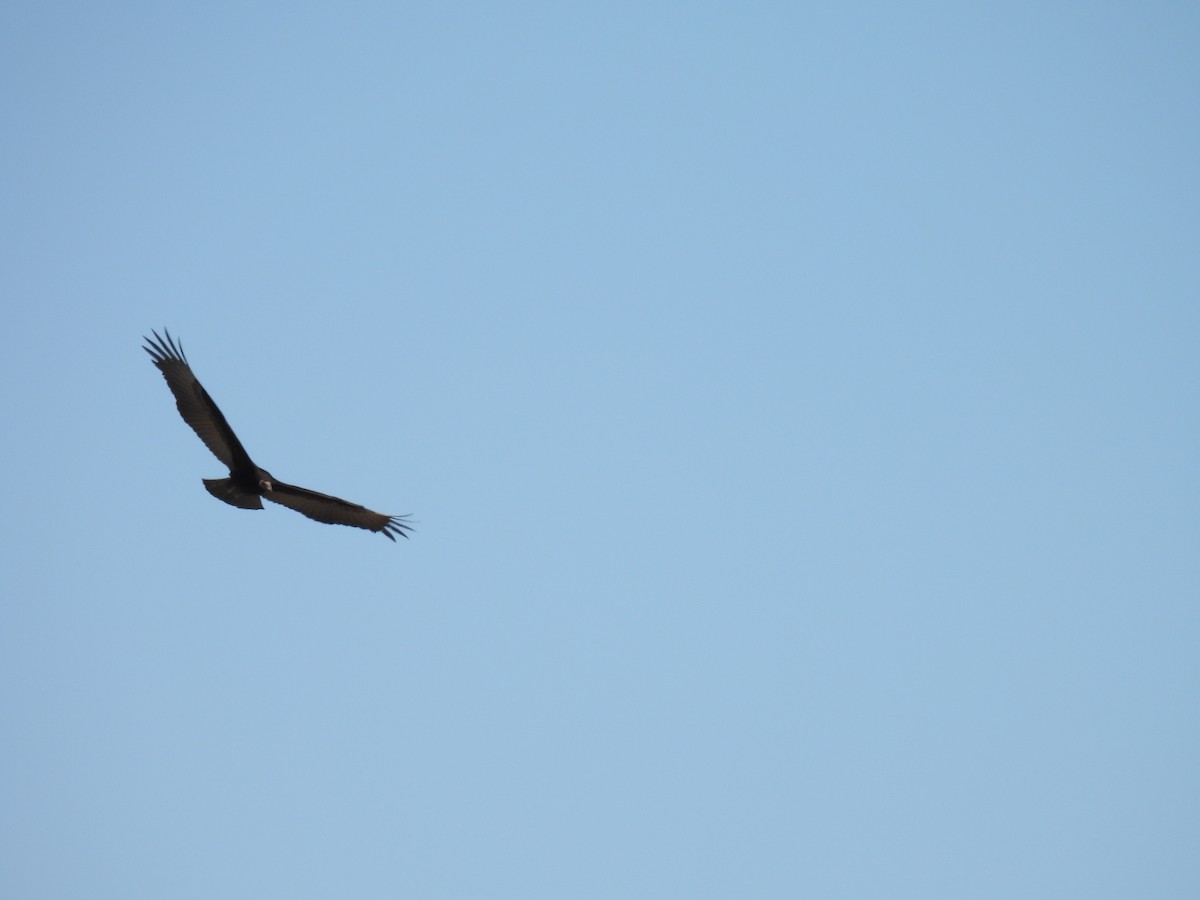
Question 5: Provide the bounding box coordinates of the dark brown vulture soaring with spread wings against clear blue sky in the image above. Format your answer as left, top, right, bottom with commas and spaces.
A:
142, 329, 412, 541
